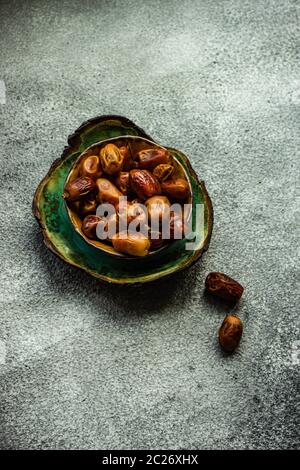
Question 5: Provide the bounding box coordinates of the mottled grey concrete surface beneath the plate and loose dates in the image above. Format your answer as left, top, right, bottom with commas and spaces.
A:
0, 0, 300, 449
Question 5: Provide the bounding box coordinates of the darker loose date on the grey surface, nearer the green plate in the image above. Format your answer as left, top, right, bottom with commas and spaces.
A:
205, 272, 244, 303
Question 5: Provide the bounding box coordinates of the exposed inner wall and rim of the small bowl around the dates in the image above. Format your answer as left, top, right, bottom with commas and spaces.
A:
65, 136, 193, 260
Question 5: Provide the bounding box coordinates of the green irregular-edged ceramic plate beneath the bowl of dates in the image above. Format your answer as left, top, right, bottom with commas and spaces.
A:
33, 116, 213, 284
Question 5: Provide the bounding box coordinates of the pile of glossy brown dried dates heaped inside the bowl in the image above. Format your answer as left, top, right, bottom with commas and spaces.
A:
63, 143, 190, 257
